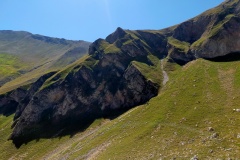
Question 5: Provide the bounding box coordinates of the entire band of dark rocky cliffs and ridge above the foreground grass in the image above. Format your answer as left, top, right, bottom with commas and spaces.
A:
0, 0, 240, 145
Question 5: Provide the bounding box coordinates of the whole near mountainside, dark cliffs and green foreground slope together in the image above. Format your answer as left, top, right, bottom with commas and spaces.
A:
0, 0, 240, 159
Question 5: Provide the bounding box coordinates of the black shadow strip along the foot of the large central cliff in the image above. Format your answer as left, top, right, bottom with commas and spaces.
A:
10, 108, 130, 149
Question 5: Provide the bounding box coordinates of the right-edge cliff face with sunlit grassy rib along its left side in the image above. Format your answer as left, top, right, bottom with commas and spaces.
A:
190, 1, 240, 58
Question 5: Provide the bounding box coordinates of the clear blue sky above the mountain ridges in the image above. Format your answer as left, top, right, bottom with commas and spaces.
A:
0, 0, 224, 42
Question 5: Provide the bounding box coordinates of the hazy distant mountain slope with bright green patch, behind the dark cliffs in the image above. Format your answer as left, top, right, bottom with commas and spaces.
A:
0, 30, 90, 92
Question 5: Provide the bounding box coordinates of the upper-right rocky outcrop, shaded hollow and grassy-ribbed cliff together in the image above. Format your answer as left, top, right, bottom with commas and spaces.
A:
169, 0, 240, 64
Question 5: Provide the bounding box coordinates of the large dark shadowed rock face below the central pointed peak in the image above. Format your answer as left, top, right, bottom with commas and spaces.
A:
10, 29, 162, 146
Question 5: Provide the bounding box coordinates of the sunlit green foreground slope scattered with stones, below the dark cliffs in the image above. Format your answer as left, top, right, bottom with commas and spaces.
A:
0, 59, 240, 159
